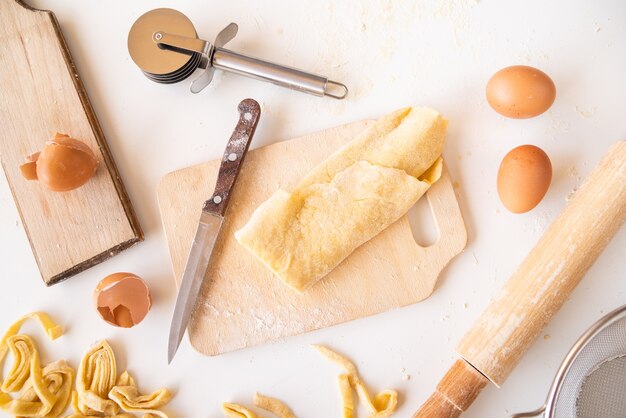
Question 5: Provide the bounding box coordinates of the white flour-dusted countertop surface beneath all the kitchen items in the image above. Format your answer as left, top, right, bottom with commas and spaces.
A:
0, 0, 626, 418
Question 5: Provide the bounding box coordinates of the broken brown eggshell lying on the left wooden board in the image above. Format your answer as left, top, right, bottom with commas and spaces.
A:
33, 134, 98, 192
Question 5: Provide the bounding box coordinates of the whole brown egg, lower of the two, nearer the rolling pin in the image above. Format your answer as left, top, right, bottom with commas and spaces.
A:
498, 145, 552, 213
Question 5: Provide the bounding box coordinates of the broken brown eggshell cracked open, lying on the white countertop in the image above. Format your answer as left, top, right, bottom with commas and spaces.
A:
93, 273, 152, 328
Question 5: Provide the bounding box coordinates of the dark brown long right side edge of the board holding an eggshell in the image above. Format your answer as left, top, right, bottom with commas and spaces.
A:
46, 8, 144, 242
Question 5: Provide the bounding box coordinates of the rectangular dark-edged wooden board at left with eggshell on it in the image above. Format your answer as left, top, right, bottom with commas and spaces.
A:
0, 0, 143, 285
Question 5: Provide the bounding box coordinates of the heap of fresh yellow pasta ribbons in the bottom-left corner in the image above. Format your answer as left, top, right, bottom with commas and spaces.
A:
0, 312, 172, 418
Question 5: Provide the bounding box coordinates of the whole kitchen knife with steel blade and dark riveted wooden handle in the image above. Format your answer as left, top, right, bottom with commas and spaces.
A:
167, 99, 261, 364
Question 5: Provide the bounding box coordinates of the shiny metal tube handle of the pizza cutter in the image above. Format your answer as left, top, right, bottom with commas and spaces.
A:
211, 48, 348, 99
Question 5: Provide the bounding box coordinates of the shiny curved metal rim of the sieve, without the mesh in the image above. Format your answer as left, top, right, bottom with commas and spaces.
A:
510, 305, 626, 418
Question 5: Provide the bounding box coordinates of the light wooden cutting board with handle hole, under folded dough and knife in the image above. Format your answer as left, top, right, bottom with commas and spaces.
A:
158, 121, 467, 355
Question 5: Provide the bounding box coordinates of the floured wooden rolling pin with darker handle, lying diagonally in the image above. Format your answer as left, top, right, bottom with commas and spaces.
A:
413, 141, 626, 418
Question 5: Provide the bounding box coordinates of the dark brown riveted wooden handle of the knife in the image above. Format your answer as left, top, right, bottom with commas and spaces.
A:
202, 99, 261, 216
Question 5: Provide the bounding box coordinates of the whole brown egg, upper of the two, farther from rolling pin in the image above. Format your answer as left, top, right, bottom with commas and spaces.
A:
487, 65, 556, 119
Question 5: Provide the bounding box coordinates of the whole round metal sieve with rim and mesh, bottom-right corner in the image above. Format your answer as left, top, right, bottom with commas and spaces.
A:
511, 305, 626, 418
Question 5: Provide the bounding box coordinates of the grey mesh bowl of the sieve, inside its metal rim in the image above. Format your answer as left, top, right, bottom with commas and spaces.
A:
546, 312, 626, 418
